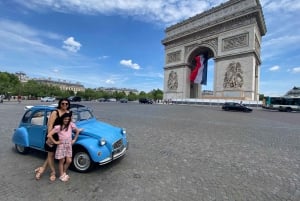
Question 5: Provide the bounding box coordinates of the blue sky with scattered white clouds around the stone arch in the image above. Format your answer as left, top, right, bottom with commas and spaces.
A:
0, 0, 300, 96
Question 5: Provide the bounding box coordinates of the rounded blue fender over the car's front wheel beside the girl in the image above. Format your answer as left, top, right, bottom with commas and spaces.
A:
73, 138, 111, 162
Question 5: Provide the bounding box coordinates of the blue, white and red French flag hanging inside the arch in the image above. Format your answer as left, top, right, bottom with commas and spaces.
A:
190, 54, 207, 85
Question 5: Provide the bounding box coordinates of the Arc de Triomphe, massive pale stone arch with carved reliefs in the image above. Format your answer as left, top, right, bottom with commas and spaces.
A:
162, 0, 266, 100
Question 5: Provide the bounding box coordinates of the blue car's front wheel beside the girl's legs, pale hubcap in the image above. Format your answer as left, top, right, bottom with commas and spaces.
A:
71, 148, 94, 173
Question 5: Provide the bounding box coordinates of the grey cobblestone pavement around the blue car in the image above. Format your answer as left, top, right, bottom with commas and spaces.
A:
0, 101, 300, 201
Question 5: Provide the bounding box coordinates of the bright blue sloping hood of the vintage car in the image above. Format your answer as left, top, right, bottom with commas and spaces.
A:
76, 119, 122, 143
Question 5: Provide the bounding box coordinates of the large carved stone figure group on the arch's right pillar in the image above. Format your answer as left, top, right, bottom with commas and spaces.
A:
223, 62, 244, 89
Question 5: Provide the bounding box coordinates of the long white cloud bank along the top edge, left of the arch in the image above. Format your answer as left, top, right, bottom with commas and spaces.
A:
16, 0, 227, 25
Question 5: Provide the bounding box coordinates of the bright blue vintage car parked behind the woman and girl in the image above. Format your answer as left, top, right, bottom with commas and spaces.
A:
12, 104, 128, 172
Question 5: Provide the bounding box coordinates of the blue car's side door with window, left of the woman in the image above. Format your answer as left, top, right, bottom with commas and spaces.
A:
27, 109, 48, 149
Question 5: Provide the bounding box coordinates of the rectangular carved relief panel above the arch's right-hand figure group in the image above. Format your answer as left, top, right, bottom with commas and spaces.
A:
222, 33, 249, 51
